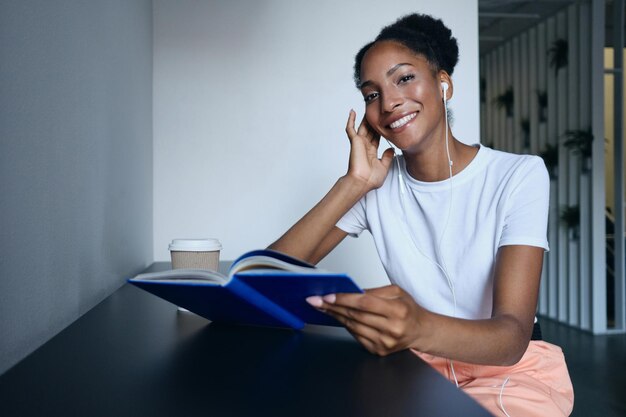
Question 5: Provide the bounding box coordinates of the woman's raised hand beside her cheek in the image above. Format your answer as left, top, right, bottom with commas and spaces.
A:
346, 110, 394, 191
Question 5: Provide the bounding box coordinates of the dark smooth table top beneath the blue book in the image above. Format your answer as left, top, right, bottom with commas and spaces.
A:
0, 264, 490, 417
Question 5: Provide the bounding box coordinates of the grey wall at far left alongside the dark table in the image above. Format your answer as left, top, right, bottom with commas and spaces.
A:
0, 0, 152, 373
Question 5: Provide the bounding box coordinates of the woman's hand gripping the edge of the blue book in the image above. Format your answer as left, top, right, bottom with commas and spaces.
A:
307, 285, 427, 356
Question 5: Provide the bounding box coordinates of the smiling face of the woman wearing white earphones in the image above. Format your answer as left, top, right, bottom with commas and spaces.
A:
361, 41, 450, 153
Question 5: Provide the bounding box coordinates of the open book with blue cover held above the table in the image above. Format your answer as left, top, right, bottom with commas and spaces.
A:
128, 250, 363, 329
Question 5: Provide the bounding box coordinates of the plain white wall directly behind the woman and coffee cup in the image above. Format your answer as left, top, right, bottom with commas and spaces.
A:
153, 0, 479, 286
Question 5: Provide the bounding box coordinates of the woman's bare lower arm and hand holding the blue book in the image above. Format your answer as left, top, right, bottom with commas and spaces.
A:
310, 245, 543, 365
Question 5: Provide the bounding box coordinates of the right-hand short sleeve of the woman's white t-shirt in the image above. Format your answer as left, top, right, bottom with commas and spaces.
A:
499, 156, 550, 247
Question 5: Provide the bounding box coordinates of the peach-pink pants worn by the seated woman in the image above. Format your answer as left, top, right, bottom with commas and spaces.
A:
413, 341, 574, 417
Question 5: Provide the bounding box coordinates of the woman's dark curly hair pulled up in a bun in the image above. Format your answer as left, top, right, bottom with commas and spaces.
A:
354, 13, 459, 88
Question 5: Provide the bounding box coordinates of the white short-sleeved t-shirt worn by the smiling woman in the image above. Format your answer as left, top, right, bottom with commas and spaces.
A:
337, 145, 550, 319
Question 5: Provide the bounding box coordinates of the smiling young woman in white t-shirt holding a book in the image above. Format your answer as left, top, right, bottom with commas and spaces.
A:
270, 14, 573, 416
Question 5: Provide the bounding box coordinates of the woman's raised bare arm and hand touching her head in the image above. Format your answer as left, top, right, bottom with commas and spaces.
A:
269, 111, 393, 263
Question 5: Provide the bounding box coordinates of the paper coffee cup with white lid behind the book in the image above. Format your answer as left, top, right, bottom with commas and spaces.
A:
169, 239, 222, 271
